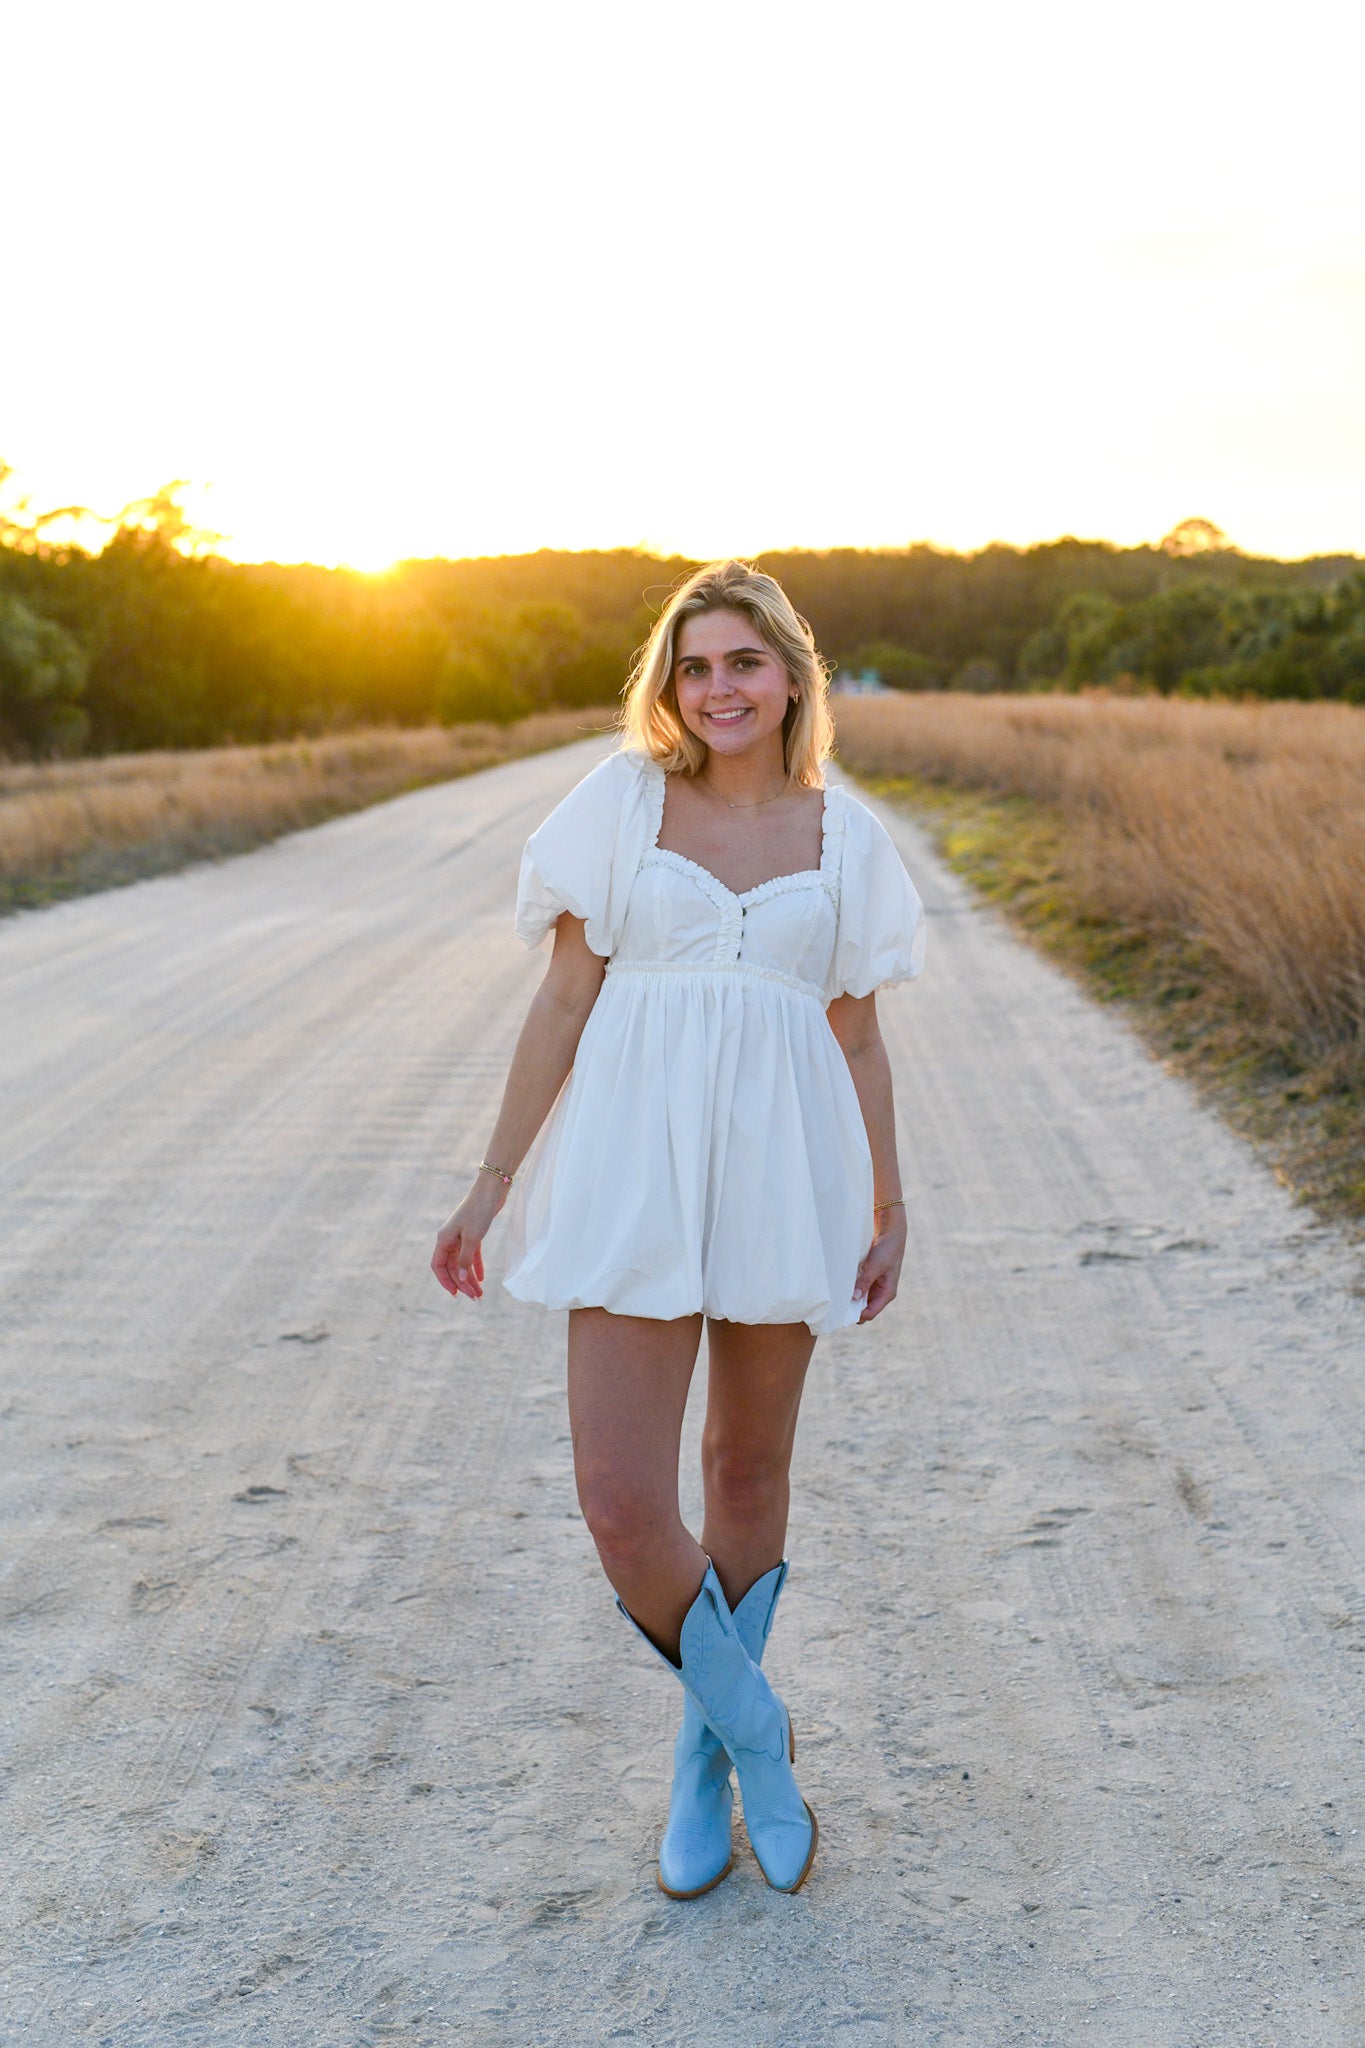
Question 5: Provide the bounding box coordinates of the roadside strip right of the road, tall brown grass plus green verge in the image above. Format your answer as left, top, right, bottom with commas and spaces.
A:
837, 694, 1365, 1223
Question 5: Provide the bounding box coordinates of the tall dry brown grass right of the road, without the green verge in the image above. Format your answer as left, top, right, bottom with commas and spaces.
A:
837, 694, 1365, 1063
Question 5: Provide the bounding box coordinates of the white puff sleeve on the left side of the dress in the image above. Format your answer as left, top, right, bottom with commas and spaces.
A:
516, 750, 651, 958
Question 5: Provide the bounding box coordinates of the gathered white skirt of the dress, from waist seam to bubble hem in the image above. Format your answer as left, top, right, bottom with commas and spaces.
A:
501, 963, 872, 1337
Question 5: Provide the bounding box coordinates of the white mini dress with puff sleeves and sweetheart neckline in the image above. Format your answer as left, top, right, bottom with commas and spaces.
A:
503, 750, 925, 1335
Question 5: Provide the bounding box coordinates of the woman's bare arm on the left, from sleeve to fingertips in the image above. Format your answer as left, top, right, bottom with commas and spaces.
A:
432, 911, 606, 1300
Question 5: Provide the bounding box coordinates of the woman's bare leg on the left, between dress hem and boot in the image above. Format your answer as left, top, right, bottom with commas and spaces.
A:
569, 1309, 706, 1663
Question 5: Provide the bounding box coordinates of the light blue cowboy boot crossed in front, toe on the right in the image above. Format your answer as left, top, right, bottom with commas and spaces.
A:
616, 1563, 819, 1892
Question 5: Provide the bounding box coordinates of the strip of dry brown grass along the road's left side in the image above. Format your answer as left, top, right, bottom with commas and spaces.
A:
0, 709, 614, 909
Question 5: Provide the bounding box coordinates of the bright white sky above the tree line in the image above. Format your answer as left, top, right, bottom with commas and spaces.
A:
0, 0, 1365, 567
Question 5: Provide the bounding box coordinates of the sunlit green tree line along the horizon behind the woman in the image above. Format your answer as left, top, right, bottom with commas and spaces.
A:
0, 483, 1365, 756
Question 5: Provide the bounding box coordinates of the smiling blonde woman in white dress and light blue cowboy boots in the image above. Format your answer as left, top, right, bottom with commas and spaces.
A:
432, 561, 923, 1898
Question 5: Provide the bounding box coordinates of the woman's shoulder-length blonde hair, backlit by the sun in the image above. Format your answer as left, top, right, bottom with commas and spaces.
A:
620, 561, 835, 788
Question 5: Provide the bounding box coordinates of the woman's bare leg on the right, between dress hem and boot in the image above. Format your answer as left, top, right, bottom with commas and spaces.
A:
702, 1321, 814, 1608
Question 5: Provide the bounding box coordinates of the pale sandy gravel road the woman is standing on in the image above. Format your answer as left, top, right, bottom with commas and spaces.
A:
0, 741, 1365, 2048
